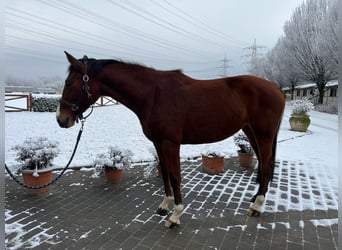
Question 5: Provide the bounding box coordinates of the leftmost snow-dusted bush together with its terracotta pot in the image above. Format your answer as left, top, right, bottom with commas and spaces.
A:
13, 137, 59, 194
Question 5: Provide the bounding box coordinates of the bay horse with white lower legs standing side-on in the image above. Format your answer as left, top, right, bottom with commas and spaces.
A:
56, 52, 285, 228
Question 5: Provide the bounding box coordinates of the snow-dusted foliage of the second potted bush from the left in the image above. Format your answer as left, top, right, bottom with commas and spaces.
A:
93, 146, 133, 177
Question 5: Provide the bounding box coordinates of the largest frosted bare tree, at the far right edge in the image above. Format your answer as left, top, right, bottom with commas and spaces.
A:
283, 0, 338, 103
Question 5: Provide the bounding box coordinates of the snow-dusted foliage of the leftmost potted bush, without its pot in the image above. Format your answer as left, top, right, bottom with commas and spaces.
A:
13, 137, 59, 170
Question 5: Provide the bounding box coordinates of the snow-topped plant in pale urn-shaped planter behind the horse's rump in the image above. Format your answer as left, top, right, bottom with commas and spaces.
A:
289, 100, 314, 132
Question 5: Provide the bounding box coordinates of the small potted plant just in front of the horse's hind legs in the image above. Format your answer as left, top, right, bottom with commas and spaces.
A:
234, 130, 254, 168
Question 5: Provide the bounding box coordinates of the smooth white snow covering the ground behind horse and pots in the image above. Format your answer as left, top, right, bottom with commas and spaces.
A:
5, 102, 337, 171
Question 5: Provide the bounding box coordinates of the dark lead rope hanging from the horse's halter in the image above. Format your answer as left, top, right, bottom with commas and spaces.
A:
5, 118, 87, 189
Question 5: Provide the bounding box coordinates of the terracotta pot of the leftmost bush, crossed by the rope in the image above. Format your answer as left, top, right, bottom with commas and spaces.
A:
21, 169, 52, 194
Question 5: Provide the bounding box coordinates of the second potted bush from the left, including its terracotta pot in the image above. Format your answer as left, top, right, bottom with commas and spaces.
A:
93, 146, 133, 183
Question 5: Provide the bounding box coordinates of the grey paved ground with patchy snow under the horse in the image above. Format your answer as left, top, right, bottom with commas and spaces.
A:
6, 159, 338, 250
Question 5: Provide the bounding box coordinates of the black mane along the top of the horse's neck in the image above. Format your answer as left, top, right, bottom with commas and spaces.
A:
68, 58, 183, 75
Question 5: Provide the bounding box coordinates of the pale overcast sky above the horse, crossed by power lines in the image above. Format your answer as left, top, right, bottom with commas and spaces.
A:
5, 0, 302, 82
